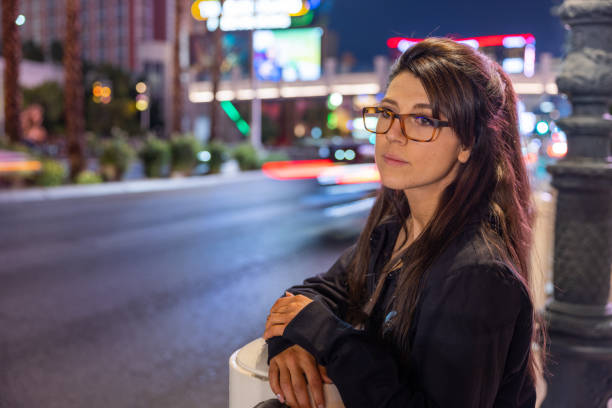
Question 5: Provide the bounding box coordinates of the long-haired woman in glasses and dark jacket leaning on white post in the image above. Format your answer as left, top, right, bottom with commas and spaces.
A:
264, 38, 543, 408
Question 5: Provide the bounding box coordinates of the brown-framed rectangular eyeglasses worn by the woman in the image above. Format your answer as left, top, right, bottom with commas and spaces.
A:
363, 107, 450, 142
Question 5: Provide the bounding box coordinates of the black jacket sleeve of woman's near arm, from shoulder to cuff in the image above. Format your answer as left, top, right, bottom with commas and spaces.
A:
283, 266, 531, 408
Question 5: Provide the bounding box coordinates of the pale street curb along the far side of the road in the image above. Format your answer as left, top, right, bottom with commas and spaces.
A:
0, 170, 267, 203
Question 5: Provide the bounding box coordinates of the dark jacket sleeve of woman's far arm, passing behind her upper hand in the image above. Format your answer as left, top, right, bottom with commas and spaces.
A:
267, 245, 356, 363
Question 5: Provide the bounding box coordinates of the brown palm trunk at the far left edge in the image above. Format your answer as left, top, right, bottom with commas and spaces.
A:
2, 0, 21, 143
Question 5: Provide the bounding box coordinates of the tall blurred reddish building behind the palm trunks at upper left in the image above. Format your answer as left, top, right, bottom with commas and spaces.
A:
0, 0, 174, 134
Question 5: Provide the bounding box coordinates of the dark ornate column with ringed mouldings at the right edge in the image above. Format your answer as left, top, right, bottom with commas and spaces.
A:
543, 0, 612, 408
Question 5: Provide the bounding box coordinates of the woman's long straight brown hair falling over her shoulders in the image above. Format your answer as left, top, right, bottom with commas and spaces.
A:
349, 38, 546, 380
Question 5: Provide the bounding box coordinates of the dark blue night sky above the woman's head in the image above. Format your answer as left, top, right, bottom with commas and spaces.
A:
328, 0, 566, 65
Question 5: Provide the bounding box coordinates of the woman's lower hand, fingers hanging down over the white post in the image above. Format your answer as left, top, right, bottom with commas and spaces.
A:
268, 345, 332, 408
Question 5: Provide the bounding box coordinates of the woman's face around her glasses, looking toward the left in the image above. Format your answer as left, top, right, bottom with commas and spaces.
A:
375, 72, 470, 193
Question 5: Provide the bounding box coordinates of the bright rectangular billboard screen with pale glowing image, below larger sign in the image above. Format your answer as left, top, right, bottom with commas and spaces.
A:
253, 27, 323, 82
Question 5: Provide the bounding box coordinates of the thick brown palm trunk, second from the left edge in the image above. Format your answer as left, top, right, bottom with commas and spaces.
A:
64, 0, 85, 180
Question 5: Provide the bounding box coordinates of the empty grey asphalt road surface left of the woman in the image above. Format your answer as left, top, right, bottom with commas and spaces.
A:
0, 177, 361, 408
